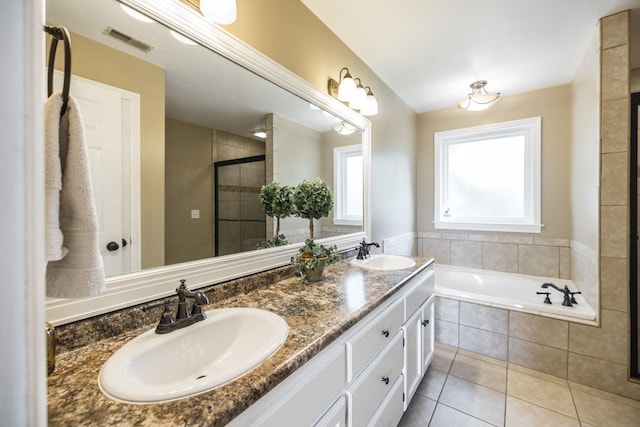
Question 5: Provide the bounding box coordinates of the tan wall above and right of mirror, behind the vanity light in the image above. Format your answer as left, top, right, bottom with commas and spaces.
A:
225, 0, 416, 241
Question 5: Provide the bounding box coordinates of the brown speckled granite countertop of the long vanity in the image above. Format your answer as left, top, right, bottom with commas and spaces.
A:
48, 258, 428, 426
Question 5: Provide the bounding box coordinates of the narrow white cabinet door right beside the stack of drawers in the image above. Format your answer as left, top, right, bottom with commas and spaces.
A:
403, 310, 423, 409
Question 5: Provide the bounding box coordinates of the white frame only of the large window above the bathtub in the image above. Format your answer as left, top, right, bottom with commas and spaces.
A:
433, 117, 543, 233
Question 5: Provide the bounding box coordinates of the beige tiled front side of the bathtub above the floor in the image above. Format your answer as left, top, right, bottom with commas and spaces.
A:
435, 297, 640, 400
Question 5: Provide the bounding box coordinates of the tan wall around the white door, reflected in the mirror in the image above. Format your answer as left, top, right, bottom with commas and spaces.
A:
47, 33, 164, 268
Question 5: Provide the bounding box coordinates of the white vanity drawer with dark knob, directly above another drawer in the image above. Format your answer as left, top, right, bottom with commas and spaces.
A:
346, 298, 404, 381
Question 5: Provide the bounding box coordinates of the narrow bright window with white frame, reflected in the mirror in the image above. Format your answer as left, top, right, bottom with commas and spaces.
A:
333, 144, 364, 225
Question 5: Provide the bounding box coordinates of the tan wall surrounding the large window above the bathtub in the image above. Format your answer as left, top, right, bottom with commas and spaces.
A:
417, 85, 571, 239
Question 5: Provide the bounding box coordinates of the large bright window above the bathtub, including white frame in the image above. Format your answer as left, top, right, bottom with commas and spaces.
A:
434, 117, 542, 233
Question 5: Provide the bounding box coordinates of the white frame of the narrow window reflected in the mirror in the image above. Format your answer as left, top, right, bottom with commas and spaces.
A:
333, 144, 364, 226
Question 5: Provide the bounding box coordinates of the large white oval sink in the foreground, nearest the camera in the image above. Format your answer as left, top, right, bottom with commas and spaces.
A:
98, 308, 289, 403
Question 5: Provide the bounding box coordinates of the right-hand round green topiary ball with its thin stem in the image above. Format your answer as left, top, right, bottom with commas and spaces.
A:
292, 178, 333, 239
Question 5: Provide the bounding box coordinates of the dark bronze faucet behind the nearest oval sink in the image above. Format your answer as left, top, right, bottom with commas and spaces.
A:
156, 279, 209, 334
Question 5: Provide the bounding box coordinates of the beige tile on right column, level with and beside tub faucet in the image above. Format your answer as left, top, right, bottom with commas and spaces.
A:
600, 257, 629, 311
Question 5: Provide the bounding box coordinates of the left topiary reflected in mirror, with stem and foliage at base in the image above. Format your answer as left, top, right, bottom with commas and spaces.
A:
257, 181, 293, 249
